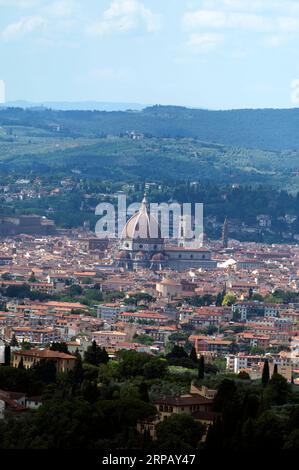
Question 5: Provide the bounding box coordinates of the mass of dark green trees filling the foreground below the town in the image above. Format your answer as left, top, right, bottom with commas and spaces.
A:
0, 344, 299, 450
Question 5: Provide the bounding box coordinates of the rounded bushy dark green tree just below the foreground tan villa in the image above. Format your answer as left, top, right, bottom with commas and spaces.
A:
156, 413, 205, 450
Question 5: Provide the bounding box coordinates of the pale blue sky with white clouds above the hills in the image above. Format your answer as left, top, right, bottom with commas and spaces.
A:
0, 0, 299, 109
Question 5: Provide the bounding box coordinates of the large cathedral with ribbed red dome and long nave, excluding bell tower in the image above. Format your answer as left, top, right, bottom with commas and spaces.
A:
115, 198, 217, 271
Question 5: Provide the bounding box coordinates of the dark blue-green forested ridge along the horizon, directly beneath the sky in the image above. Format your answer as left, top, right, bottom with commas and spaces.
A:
0, 105, 299, 150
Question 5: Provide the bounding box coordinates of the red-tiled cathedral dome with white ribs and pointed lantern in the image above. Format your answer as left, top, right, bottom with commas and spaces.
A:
121, 197, 161, 240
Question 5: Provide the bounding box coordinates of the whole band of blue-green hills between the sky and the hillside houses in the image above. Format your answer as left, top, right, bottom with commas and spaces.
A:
0, 106, 299, 190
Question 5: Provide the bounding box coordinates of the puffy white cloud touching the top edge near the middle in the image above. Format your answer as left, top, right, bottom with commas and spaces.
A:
88, 0, 160, 36
